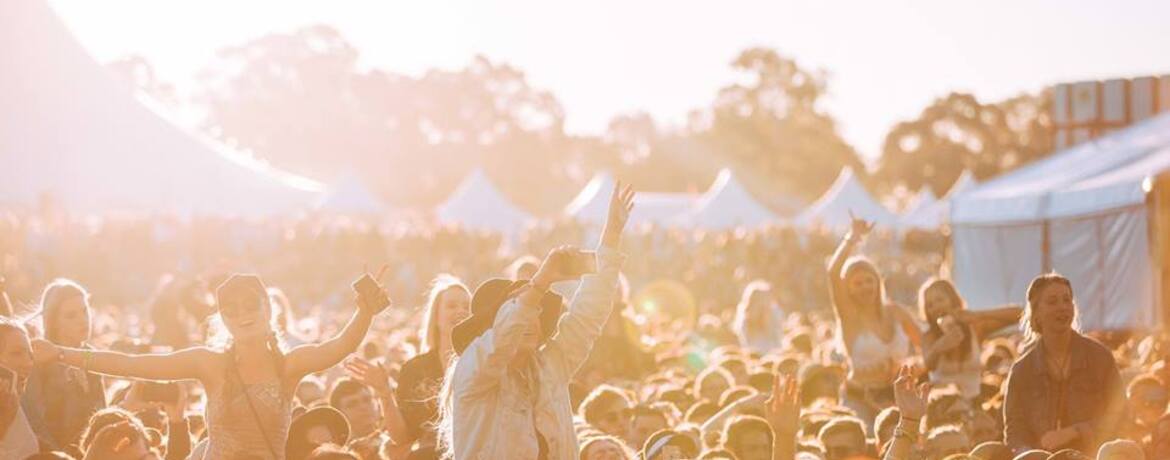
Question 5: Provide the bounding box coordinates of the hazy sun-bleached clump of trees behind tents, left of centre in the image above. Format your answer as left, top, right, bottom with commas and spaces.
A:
197, 26, 573, 210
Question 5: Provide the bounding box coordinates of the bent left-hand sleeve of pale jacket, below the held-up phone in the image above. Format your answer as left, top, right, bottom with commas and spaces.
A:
453, 296, 539, 398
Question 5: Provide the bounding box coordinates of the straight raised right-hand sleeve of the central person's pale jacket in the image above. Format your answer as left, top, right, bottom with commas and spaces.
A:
542, 247, 626, 384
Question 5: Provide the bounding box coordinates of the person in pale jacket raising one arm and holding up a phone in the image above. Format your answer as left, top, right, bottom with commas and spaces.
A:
439, 184, 633, 460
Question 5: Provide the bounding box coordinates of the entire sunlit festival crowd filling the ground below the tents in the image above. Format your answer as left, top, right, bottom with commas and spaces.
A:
0, 184, 1170, 460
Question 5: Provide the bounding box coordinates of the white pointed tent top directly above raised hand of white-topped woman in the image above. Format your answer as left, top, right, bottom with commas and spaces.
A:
794, 167, 899, 229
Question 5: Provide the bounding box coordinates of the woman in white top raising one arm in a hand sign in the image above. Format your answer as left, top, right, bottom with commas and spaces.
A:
828, 218, 918, 424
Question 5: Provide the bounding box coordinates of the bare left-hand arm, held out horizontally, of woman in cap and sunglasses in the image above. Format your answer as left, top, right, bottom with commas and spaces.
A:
33, 339, 218, 380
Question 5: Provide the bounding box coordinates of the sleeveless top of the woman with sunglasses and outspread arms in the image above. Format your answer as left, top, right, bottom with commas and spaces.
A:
204, 380, 293, 460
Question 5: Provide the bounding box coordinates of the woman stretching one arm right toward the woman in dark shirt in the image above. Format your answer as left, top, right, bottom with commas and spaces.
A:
918, 277, 1023, 400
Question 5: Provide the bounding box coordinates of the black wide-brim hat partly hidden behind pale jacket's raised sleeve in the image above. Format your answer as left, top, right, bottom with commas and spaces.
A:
450, 279, 564, 355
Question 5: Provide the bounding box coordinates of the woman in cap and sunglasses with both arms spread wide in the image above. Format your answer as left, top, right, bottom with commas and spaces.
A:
26, 269, 390, 460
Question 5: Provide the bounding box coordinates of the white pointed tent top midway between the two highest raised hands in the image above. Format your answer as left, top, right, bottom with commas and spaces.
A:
674, 167, 780, 229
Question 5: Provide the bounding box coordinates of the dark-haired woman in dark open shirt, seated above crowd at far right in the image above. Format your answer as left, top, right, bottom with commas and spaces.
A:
1004, 273, 1126, 454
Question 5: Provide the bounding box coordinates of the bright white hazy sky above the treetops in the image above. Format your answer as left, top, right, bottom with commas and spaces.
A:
49, 0, 1170, 156
